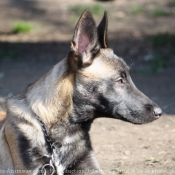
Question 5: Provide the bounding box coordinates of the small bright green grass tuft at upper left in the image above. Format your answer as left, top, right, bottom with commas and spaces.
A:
12, 21, 33, 33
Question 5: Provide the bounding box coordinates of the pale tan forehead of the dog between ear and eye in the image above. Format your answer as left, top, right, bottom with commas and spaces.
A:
82, 49, 128, 78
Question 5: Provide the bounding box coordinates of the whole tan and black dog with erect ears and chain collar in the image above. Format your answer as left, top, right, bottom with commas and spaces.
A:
0, 10, 162, 175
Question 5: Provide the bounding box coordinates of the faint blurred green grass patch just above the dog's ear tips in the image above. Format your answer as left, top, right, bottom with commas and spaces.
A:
69, 4, 105, 15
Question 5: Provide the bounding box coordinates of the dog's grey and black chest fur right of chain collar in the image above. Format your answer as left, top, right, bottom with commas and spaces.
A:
47, 121, 91, 172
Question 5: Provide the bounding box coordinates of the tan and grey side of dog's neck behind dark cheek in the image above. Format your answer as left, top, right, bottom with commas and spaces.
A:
26, 59, 74, 125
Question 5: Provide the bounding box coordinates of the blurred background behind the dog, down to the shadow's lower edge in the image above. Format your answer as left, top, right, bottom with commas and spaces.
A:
0, 0, 175, 114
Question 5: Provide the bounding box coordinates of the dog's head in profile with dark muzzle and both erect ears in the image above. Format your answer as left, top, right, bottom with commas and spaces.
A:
68, 11, 162, 124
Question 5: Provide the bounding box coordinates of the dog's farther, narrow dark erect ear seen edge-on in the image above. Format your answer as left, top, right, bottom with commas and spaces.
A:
98, 11, 108, 48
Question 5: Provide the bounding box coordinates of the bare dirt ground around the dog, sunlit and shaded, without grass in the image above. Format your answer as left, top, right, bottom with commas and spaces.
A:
0, 0, 175, 175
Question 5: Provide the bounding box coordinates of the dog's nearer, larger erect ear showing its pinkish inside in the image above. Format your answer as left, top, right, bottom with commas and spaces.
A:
68, 10, 100, 70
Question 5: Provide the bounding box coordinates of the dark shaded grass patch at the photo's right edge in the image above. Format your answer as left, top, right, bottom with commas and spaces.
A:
136, 33, 175, 75
